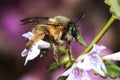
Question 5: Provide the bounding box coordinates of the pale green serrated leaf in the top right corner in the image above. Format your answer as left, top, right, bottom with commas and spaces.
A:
105, 0, 120, 19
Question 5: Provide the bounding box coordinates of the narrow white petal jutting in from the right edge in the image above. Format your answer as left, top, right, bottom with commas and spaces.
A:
102, 52, 120, 61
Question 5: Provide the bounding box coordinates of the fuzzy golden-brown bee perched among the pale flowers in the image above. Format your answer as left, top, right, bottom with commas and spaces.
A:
21, 16, 83, 61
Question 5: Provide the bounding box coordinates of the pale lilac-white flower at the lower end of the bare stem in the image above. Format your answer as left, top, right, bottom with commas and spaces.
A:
76, 44, 107, 76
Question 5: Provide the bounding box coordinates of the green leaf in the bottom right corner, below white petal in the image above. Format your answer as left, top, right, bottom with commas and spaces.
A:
104, 61, 120, 79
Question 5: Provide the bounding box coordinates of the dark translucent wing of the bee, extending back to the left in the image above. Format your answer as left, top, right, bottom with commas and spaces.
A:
21, 17, 49, 25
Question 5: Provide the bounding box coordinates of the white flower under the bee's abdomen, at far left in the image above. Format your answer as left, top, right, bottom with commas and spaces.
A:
21, 32, 50, 65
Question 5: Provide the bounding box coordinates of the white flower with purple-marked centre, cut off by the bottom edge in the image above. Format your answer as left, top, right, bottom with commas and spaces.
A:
61, 63, 91, 80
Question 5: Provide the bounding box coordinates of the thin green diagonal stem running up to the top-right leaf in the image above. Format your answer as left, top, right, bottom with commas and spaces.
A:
79, 15, 115, 56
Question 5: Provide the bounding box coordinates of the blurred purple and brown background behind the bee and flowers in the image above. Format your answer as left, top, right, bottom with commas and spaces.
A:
0, 0, 120, 80
